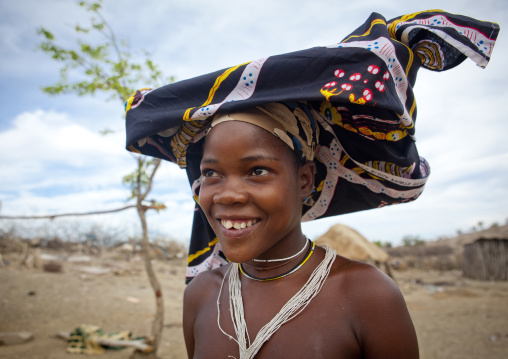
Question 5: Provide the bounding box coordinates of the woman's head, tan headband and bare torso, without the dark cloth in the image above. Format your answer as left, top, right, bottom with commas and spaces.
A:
184, 103, 418, 359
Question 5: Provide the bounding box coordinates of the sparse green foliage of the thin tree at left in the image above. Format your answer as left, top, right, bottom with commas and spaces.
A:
37, 0, 169, 205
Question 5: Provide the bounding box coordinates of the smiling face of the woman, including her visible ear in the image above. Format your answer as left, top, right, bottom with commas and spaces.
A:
199, 121, 314, 263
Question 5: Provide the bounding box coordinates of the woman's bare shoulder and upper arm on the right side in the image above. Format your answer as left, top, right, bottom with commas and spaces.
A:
329, 252, 418, 358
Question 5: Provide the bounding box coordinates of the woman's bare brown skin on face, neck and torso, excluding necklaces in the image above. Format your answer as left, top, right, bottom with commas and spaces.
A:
183, 122, 419, 359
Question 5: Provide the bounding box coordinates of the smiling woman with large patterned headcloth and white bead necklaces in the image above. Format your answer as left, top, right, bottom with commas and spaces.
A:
127, 11, 499, 359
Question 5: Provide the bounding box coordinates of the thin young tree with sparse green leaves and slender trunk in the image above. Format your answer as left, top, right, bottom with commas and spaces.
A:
37, 0, 173, 358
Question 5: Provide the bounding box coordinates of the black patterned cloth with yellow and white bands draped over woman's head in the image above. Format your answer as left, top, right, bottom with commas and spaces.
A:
126, 10, 499, 281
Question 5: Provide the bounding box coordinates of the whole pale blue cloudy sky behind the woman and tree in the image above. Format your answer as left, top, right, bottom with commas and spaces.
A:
0, 0, 508, 245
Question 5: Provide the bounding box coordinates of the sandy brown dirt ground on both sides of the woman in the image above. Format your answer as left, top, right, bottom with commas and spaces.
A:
0, 254, 508, 359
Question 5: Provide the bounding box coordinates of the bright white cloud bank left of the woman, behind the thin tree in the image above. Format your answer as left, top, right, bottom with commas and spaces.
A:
0, 110, 194, 241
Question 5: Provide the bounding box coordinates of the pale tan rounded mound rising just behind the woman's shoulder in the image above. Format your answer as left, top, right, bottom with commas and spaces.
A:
316, 224, 389, 262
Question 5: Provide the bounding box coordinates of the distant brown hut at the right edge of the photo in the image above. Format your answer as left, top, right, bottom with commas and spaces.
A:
462, 238, 508, 280
